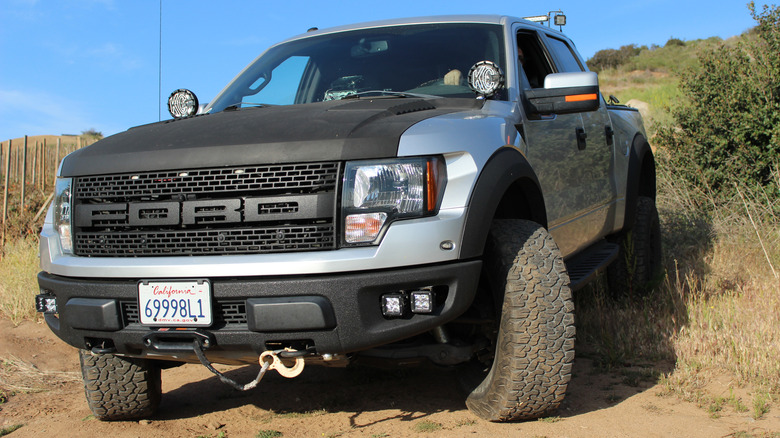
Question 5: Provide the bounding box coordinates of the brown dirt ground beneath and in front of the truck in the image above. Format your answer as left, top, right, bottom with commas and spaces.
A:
0, 320, 780, 438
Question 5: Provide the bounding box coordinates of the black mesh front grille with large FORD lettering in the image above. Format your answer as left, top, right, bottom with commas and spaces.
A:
73, 163, 340, 257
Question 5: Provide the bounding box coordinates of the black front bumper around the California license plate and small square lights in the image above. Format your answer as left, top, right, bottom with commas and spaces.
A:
38, 261, 482, 363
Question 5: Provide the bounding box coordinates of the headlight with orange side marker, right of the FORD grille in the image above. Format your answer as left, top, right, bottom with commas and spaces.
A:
342, 157, 447, 244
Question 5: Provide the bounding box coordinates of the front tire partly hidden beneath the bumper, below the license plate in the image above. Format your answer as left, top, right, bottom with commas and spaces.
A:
79, 350, 162, 421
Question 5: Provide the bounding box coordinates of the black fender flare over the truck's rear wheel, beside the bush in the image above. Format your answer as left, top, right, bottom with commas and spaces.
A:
623, 133, 656, 231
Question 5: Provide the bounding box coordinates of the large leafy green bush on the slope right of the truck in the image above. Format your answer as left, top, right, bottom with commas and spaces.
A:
658, 3, 780, 210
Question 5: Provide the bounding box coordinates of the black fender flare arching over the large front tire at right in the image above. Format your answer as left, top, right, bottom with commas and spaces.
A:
460, 146, 547, 259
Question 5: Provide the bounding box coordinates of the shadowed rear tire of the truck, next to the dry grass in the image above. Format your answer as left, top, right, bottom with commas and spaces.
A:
607, 196, 662, 298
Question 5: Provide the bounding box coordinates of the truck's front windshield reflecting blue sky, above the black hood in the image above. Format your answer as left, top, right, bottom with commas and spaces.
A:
209, 23, 506, 112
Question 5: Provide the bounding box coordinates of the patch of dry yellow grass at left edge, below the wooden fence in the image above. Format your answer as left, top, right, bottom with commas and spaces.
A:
0, 238, 38, 325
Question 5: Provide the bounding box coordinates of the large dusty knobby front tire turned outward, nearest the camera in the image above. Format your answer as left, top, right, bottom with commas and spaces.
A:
466, 220, 575, 421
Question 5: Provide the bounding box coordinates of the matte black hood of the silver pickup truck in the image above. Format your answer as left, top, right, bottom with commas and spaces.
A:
62, 97, 484, 177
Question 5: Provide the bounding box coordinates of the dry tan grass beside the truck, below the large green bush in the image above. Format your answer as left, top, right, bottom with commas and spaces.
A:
575, 159, 780, 418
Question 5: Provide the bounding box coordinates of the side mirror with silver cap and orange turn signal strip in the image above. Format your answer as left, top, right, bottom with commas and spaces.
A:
525, 72, 599, 115
